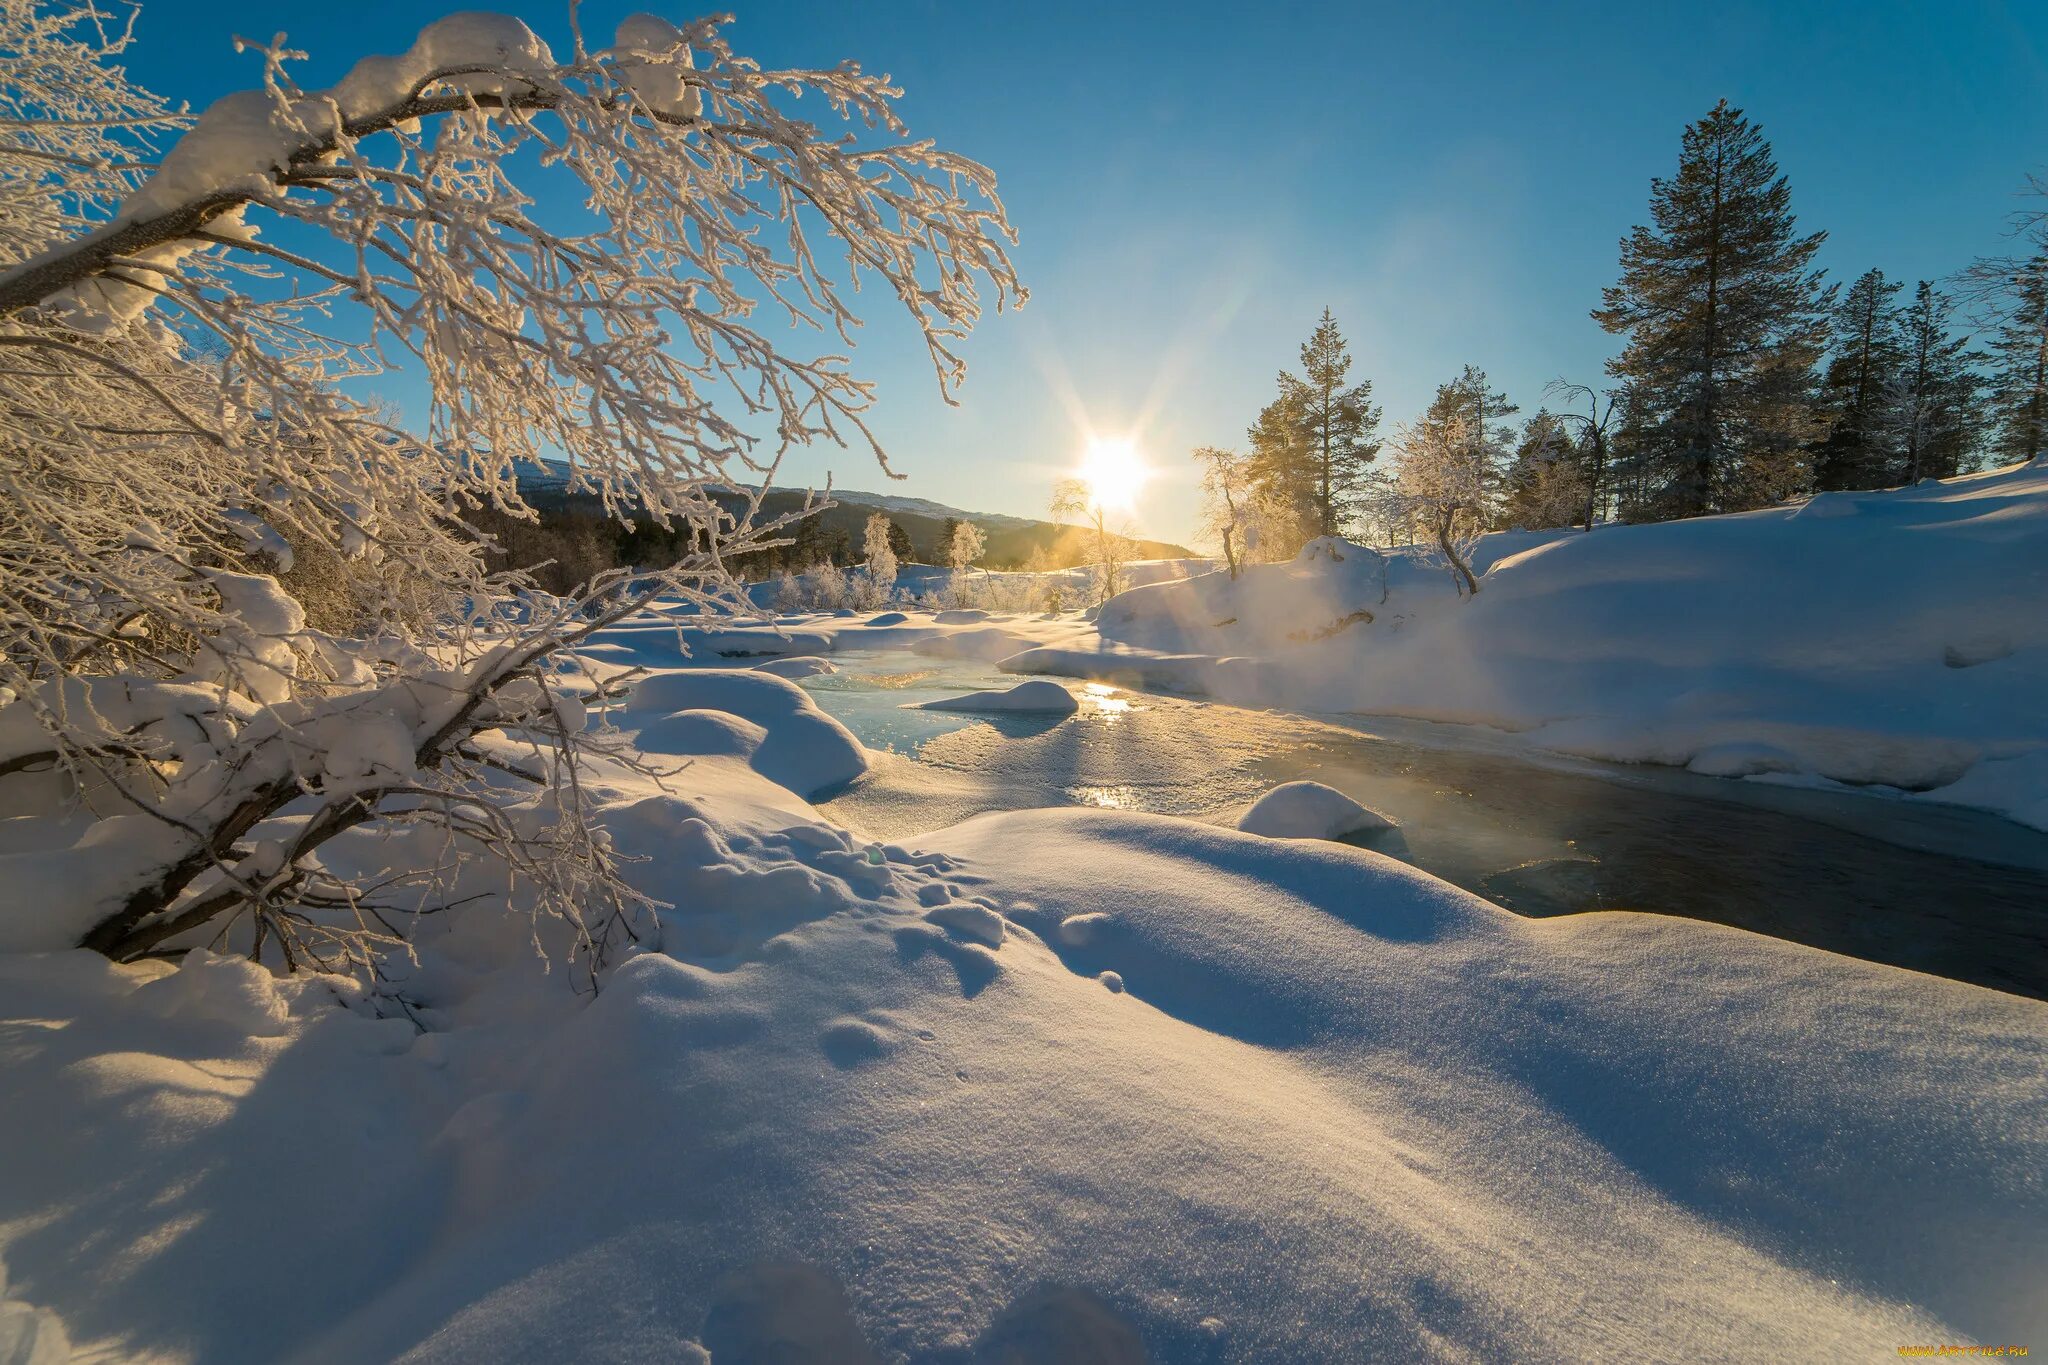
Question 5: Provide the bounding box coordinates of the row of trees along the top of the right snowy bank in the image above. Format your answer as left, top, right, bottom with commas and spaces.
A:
1196, 100, 2048, 564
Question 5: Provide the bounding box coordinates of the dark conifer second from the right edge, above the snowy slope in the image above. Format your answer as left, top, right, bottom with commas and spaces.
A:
1880, 280, 1985, 483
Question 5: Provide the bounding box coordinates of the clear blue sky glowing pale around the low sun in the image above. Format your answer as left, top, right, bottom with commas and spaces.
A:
129, 0, 2048, 538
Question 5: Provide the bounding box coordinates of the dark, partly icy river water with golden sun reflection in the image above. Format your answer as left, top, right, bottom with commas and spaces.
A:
803, 651, 2048, 999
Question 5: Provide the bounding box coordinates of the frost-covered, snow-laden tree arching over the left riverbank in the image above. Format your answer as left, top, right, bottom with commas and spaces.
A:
0, 0, 1024, 982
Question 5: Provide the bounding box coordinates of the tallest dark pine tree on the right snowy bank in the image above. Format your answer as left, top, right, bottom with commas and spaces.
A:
1593, 100, 1833, 516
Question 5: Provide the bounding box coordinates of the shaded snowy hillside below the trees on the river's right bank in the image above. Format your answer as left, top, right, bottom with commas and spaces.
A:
1008, 463, 2048, 827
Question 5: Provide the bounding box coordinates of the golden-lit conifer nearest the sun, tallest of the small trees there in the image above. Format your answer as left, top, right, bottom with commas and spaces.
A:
1253, 309, 1380, 536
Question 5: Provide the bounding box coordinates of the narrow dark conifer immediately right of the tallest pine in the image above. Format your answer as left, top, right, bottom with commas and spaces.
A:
1812, 270, 1905, 489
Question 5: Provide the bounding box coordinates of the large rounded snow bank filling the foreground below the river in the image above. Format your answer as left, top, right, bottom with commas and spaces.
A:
0, 789, 2048, 1365
